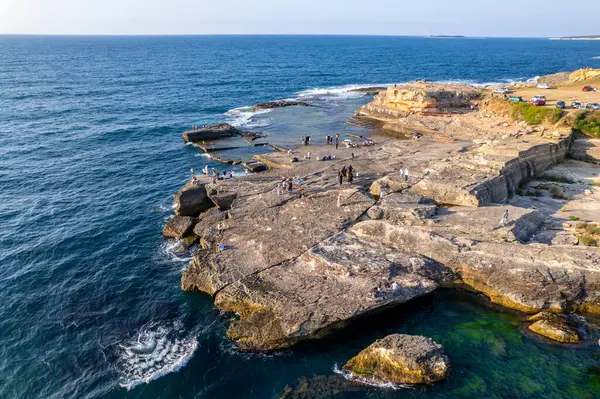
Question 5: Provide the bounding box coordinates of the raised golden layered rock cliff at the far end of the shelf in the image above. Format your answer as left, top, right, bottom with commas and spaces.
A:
357, 83, 480, 120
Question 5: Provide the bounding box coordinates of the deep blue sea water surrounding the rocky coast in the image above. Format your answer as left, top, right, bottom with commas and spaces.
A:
0, 36, 600, 398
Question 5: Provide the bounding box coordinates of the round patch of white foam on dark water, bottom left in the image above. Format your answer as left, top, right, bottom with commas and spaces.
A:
118, 322, 198, 390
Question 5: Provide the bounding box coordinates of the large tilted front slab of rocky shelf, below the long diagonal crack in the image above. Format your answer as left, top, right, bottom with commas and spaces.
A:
215, 233, 446, 350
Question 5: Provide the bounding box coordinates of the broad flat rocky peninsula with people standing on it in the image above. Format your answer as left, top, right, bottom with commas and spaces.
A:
165, 76, 600, 360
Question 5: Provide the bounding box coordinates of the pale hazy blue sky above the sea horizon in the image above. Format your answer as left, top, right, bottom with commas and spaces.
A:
0, 0, 600, 37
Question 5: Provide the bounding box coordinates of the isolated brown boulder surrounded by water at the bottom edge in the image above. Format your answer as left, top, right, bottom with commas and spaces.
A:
344, 334, 450, 384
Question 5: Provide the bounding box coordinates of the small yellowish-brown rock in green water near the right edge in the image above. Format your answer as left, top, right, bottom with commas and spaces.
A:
529, 312, 584, 344
